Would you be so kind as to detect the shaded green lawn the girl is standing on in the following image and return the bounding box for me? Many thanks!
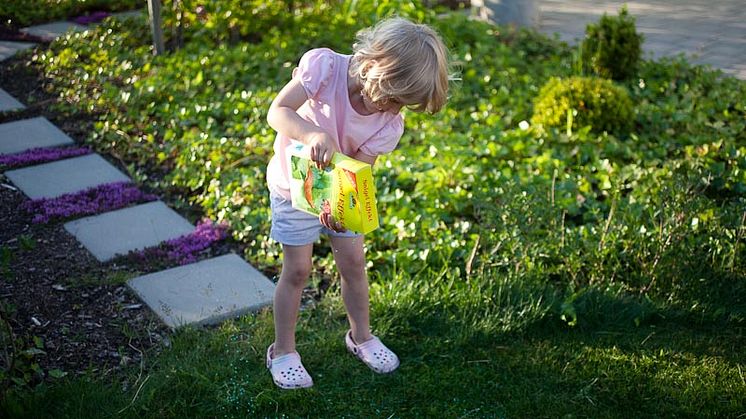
[0,278,746,418]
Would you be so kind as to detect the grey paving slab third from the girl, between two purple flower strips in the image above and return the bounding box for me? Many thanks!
[5,154,130,199]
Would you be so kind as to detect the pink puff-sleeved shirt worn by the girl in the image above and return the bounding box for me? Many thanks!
[267,48,404,199]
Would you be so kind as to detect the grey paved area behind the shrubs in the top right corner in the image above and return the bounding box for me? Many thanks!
[537,0,746,80]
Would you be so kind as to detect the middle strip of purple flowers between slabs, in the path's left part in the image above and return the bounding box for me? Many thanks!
[21,182,158,223]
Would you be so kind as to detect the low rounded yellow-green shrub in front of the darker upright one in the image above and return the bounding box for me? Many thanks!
[532,77,632,134]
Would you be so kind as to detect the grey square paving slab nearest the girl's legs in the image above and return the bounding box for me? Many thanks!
[127,254,275,328]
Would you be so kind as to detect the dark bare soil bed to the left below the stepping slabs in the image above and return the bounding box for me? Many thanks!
[0,180,168,383]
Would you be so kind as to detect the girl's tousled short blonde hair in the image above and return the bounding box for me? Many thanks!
[349,17,449,113]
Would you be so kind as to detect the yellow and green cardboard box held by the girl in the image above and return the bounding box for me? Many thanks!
[286,143,378,234]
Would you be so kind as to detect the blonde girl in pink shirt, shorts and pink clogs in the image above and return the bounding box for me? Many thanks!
[267,18,448,388]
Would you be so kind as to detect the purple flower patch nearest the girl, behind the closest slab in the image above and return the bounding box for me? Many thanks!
[135,218,228,265]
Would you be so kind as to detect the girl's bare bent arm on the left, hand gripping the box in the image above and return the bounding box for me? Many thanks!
[267,79,339,166]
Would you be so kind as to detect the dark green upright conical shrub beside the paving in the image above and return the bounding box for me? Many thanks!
[582,6,643,80]
